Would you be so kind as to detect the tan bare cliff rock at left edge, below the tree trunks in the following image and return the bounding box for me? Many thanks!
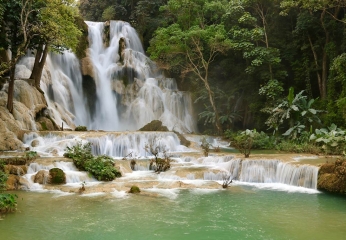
[0,80,55,151]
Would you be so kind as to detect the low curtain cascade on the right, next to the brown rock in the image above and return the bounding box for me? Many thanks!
[239,160,319,189]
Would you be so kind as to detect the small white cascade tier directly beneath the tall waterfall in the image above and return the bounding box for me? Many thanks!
[87,132,190,158]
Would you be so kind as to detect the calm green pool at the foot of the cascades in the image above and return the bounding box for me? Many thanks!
[0,186,346,239]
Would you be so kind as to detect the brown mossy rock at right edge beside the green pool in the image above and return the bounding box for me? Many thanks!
[317,159,346,194]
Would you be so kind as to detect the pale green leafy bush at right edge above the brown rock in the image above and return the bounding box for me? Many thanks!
[310,124,346,154]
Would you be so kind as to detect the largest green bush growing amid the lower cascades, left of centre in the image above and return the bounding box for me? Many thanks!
[64,143,121,181]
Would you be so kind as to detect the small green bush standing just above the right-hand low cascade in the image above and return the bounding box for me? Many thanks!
[231,129,258,158]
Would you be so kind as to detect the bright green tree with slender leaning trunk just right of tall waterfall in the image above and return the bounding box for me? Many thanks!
[148,0,231,133]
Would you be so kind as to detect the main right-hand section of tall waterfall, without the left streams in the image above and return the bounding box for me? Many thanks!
[86,21,196,132]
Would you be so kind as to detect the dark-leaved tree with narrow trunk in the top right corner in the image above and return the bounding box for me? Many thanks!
[280,0,346,99]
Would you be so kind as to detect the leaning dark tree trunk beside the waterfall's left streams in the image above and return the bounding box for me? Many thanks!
[30,44,48,93]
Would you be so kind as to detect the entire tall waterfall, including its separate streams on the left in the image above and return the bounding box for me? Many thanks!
[16,21,196,133]
